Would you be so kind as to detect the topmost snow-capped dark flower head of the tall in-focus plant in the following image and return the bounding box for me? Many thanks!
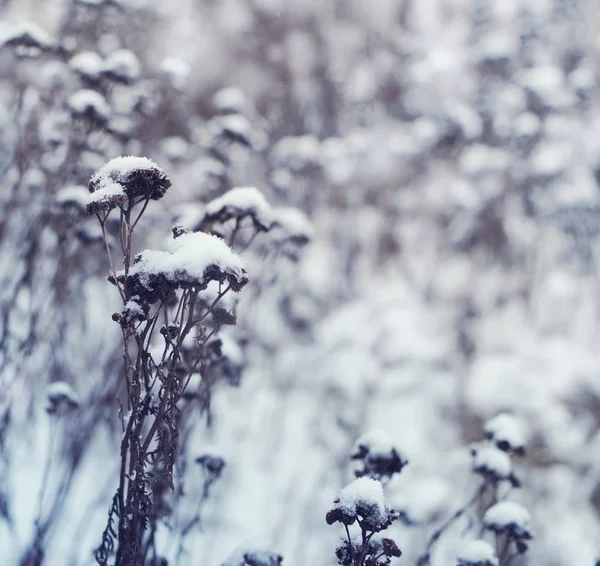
[89,156,171,204]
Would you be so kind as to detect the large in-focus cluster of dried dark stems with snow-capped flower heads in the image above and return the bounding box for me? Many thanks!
[86,156,308,566]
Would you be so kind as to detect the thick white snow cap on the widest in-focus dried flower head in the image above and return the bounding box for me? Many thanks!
[129,232,243,280]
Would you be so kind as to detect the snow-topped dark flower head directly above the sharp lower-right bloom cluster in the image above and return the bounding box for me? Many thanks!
[350,430,408,481]
